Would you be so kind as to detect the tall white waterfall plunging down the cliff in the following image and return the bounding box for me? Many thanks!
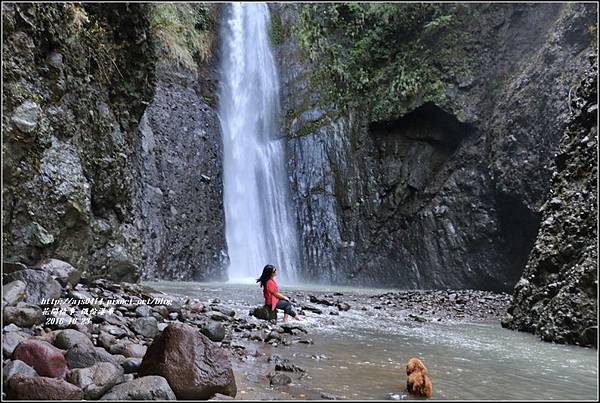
[219,3,298,283]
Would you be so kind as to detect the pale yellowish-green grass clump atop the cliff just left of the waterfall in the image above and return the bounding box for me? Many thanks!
[150,3,215,68]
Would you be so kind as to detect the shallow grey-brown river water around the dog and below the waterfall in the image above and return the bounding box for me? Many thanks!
[148,281,598,400]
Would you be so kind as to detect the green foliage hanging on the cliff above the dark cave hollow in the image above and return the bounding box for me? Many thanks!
[295,3,455,120]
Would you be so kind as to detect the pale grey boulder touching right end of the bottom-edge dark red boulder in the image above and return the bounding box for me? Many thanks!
[67,362,123,400]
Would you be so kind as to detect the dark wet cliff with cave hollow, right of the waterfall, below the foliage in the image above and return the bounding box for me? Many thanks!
[271,4,596,290]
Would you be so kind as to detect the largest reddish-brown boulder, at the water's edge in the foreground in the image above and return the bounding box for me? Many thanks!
[139,323,237,400]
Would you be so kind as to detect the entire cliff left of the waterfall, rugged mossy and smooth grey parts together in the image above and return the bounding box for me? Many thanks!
[2,3,227,282]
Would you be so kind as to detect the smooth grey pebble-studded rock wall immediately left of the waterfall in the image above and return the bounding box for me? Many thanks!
[136,63,227,280]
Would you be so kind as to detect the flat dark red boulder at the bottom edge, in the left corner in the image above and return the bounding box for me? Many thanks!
[8,374,83,400]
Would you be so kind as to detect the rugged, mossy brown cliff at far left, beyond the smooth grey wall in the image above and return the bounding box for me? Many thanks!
[2,3,153,280]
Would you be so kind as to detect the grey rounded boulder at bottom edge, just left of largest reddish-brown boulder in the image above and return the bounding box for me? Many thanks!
[100,376,177,400]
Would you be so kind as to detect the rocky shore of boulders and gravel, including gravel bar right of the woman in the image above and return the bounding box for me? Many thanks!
[2,259,510,400]
